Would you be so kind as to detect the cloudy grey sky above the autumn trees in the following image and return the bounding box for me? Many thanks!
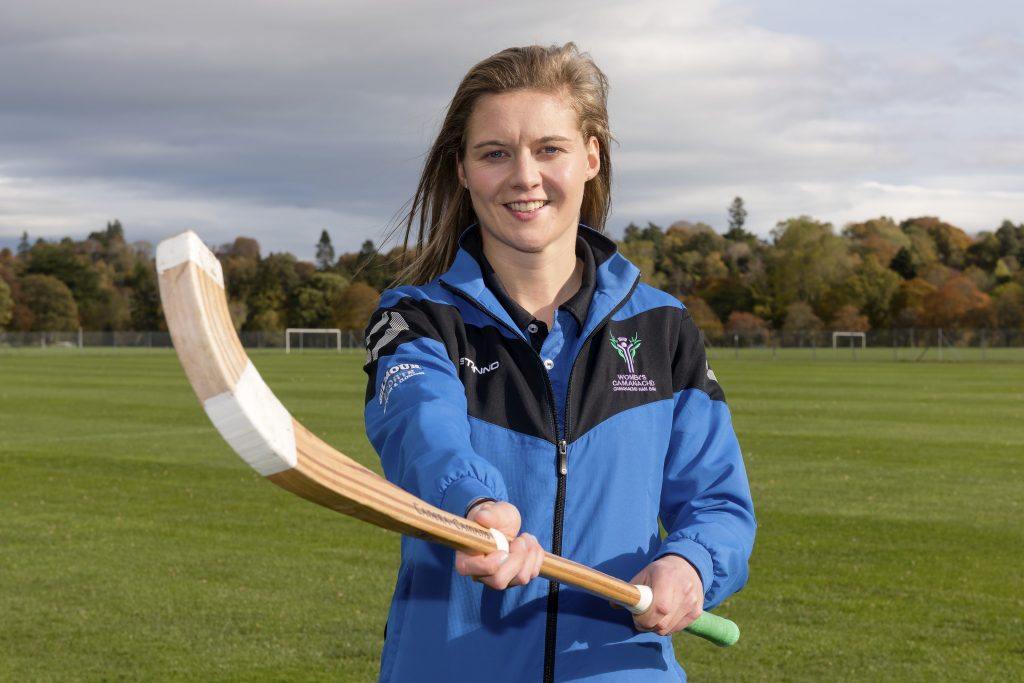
[0,0,1024,258]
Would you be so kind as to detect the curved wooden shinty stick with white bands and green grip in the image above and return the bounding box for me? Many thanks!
[157,231,739,647]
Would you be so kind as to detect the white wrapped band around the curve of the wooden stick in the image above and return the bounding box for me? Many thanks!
[203,360,298,476]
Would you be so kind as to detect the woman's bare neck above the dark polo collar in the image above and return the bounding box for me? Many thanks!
[483,242,583,329]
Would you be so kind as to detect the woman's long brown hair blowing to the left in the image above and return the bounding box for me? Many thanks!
[395,43,612,285]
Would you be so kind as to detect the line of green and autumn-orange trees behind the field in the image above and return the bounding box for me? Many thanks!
[0,198,1024,339]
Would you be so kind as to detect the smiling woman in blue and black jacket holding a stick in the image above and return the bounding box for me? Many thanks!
[366,43,755,682]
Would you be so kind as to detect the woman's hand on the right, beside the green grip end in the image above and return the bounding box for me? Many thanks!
[630,555,703,636]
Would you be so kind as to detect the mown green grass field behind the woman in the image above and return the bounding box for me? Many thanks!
[0,349,1024,682]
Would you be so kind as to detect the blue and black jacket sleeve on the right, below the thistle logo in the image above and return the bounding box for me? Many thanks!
[657,311,757,609]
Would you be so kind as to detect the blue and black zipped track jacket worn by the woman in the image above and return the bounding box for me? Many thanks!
[366,226,755,683]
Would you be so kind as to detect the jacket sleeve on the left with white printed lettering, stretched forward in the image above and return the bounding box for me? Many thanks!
[364,292,508,515]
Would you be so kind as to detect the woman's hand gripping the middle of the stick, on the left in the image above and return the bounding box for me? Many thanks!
[455,502,544,590]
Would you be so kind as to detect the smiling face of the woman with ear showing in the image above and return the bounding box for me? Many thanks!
[459,90,601,256]
